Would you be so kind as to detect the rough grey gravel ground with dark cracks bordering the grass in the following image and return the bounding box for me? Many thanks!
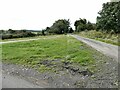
[2,53,118,88]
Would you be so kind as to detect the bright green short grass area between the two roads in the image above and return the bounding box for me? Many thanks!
[2,35,94,70]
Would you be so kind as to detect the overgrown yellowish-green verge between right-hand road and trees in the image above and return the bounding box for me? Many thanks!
[79,30,120,46]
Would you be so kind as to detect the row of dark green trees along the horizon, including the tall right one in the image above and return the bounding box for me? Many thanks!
[43,2,120,34]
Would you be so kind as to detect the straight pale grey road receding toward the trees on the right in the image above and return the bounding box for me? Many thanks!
[70,35,120,61]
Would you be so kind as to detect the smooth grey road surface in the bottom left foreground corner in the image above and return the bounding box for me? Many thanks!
[2,73,42,88]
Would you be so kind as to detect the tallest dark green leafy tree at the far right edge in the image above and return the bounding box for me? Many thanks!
[97,2,120,33]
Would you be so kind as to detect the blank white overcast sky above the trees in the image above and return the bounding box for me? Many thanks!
[0,0,110,30]
